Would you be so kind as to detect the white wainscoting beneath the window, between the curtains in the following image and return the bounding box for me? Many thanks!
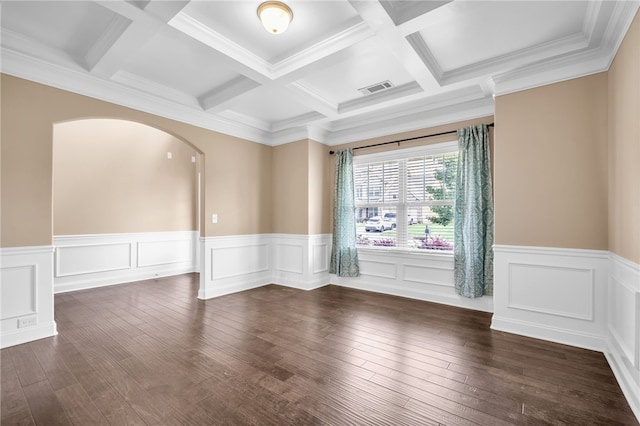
[331,249,493,312]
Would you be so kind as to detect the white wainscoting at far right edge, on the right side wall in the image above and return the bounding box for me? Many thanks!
[605,253,640,421]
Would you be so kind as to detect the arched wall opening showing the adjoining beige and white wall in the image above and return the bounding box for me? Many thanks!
[52,118,202,292]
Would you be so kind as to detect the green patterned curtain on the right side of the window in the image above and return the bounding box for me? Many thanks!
[453,124,493,298]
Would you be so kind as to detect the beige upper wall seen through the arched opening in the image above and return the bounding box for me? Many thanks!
[53,119,199,235]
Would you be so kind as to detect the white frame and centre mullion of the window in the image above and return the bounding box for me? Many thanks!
[353,140,458,256]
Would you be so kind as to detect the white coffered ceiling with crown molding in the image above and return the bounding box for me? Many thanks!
[0,0,640,145]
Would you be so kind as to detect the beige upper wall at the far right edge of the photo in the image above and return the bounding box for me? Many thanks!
[608,14,640,263]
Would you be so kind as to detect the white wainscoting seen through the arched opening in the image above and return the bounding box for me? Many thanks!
[53,231,199,293]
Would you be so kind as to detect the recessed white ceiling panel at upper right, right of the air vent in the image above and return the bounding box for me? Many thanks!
[420,1,587,71]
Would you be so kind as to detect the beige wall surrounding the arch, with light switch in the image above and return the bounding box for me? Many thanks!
[0,74,272,247]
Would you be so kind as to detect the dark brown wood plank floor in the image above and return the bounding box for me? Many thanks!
[1,274,638,426]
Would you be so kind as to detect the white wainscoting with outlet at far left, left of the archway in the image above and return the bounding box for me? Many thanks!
[0,246,57,348]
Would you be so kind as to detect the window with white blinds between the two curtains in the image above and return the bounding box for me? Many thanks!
[354,142,458,251]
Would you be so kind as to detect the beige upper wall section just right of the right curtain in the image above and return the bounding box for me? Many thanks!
[494,73,607,250]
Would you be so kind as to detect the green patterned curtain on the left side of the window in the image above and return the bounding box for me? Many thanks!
[329,149,360,277]
